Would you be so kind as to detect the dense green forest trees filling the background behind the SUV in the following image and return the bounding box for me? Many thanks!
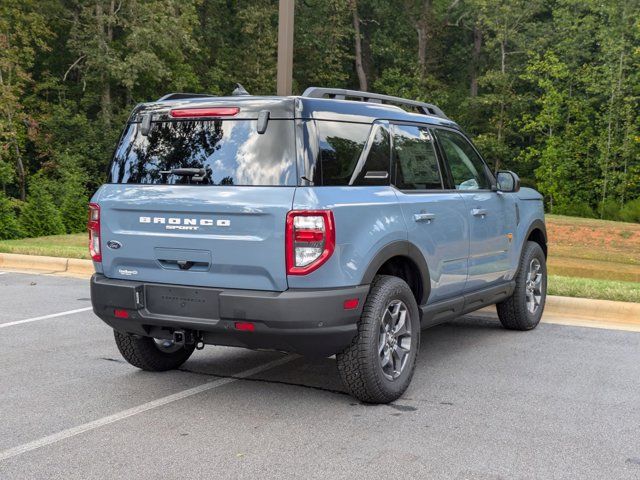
[0,0,640,235]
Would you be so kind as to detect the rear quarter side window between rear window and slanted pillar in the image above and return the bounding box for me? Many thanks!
[317,120,371,186]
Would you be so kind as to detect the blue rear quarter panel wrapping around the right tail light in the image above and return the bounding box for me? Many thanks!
[288,187,407,288]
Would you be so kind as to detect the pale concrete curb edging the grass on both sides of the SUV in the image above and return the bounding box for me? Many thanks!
[0,253,640,331]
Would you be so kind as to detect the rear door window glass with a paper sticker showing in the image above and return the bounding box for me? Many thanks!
[393,125,442,190]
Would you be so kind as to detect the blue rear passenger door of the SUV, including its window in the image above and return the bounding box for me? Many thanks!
[392,124,469,304]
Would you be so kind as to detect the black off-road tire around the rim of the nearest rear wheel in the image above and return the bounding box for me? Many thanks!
[336,275,420,403]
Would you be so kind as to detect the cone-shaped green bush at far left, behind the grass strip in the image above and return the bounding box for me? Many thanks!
[20,175,66,237]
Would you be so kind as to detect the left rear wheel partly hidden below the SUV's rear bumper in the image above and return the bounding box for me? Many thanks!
[113,330,195,372]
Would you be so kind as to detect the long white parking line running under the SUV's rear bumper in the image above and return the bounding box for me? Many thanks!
[0,355,298,462]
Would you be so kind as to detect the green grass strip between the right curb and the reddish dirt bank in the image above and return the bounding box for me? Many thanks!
[549,275,640,303]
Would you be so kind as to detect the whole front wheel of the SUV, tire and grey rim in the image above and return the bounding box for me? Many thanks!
[497,242,547,330]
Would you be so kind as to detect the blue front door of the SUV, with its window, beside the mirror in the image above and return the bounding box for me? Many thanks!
[435,128,516,291]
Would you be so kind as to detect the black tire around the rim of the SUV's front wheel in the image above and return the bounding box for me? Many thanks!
[496,242,547,331]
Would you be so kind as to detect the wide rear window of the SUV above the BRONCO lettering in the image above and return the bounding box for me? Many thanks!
[108,120,297,186]
